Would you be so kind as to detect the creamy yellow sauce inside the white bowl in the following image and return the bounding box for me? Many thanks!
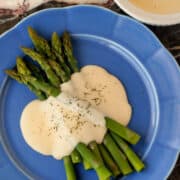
[129,0,180,14]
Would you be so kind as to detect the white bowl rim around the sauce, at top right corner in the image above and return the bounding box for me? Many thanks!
[114,0,180,26]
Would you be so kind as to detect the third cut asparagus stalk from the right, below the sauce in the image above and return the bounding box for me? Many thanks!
[103,134,133,175]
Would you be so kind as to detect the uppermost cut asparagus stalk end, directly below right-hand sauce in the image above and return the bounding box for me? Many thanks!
[105,117,140,144]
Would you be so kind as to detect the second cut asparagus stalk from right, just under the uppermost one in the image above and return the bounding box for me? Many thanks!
[111,132,145,172]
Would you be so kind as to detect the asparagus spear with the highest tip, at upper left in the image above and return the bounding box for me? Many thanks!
[28,27,55,59]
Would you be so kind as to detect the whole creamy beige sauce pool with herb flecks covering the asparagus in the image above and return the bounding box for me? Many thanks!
[20,66,131,159]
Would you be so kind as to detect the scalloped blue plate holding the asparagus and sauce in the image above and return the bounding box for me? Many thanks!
[0,6,180,180]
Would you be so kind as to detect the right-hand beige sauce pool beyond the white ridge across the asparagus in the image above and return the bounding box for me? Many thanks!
[61,65,131,125]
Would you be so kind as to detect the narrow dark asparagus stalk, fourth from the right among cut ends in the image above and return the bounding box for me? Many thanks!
[98,144,121,177]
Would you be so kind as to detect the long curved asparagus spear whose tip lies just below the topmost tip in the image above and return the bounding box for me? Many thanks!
[21,47,60,87]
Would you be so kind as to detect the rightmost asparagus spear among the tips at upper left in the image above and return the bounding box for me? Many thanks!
[62,32,79,72]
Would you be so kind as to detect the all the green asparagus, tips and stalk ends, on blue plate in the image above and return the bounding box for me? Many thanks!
[6,27,144,180]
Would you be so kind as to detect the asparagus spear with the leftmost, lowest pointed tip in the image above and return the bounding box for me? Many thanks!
[5,70,46,100]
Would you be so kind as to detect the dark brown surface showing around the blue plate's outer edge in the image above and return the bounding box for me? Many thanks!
[0,2,180,180]
